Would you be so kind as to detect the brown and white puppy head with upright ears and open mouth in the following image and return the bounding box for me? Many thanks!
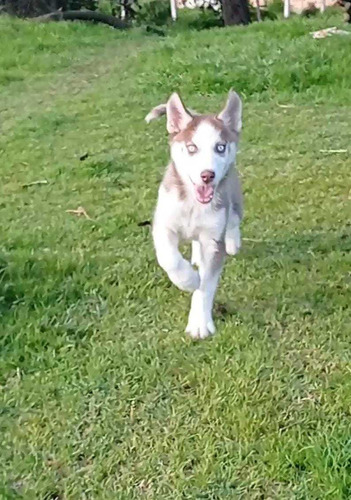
[166,91,242,204]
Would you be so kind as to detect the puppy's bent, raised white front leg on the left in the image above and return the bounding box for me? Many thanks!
[153,225,200,292]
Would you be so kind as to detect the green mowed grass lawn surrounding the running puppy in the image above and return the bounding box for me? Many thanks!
[0,9,351,500]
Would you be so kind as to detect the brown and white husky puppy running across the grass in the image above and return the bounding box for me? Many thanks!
[145,91,242,338]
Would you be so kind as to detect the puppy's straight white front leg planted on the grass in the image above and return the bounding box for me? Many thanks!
[186,240,225,339]
